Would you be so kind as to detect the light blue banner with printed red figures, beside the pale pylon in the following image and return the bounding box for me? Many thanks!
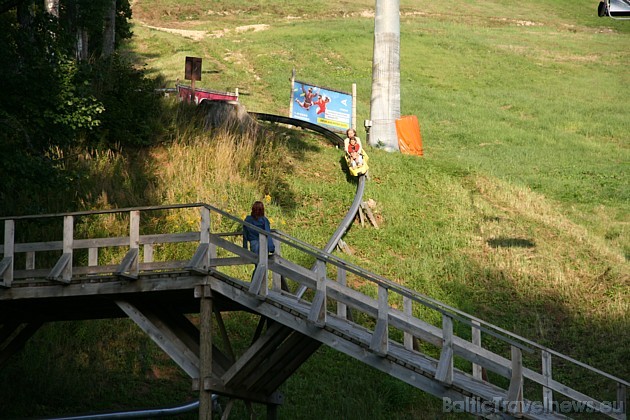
[291,80,352,132]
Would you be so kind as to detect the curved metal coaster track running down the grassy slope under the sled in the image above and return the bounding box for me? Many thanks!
[249,112,365,299]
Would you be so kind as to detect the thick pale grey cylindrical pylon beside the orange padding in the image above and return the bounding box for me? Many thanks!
[369,0,400,152]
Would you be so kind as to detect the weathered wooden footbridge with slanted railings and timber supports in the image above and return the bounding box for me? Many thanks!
[0,204,628,419]
